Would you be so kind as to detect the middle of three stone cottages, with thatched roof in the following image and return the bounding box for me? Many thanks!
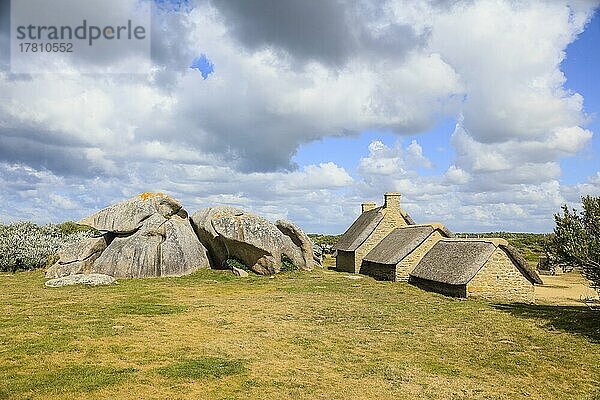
[360,223,453,282]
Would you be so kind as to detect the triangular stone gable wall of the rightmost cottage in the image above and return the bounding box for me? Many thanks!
[467,247,535,303]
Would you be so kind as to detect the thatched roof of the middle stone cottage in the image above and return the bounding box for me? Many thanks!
[364,224,452,265]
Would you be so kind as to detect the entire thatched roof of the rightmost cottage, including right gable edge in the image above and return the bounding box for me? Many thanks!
[410,239,543,285]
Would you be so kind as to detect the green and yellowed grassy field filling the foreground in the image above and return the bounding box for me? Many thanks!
[0,264,600,400]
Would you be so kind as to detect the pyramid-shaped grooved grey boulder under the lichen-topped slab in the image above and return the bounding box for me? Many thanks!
[92,214,209,278]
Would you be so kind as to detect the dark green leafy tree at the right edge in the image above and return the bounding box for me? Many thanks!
[549,196,600,293]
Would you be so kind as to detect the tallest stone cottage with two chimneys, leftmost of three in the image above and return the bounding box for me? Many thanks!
[335,192,415,273]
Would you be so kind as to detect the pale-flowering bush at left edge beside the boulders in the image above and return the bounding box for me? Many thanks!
[0,222,91,272]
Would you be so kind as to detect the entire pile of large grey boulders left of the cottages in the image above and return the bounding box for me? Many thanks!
[46,193,320,278]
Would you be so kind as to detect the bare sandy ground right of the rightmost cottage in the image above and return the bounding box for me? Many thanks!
[535,271,598,306]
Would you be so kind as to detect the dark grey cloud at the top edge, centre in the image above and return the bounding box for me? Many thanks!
[213,0,426,68]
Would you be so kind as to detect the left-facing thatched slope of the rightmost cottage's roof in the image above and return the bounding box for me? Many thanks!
[410,240,496,285]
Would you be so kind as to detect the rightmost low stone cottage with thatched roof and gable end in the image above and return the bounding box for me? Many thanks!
[409,239,543,303]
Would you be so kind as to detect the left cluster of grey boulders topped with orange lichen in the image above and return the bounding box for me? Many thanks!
[46,193,209,278]
